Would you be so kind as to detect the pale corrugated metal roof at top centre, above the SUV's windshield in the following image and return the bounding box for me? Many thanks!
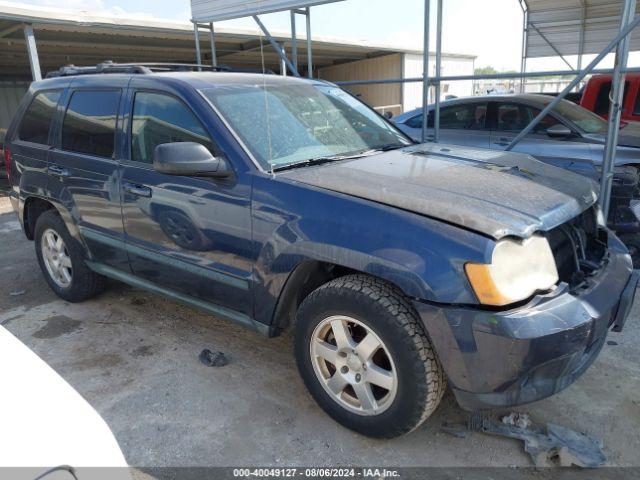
[191,0,342,22]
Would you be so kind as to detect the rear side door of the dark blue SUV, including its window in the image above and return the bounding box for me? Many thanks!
[48,75,129,270]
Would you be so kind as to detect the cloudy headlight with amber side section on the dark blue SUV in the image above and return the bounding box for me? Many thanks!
[465,235,558,306]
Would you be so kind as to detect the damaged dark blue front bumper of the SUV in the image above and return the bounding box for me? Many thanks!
[414,236,638,410]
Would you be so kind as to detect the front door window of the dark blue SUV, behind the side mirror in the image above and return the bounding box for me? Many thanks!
[131,92,215,163]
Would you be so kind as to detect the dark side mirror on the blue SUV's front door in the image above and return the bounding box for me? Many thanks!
[153,142,231,178]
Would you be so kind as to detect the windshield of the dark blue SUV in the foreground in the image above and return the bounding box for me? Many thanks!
[203,82,411,169]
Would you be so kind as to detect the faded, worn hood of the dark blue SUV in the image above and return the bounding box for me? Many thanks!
[278,144,597,239]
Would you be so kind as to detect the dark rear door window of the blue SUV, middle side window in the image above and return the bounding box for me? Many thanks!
[62,90,120,158]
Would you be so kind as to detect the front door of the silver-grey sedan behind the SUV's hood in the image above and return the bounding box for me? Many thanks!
[491,102,593,174]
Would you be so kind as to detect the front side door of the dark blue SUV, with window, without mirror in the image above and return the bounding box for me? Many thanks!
[121,89,253,316]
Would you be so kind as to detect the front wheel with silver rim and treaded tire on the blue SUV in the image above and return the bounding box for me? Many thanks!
[295,274,446,438]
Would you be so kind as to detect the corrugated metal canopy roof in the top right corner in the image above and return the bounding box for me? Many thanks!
[524,0,640,58]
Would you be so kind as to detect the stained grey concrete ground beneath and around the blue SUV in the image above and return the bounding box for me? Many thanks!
[0,177,640,467]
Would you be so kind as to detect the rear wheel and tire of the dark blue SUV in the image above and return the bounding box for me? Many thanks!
[34,210,105,302]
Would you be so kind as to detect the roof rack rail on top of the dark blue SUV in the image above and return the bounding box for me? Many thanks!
[46,60,232,78]
